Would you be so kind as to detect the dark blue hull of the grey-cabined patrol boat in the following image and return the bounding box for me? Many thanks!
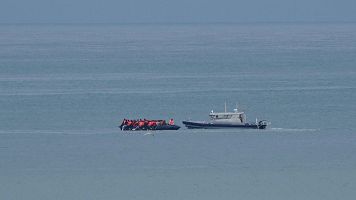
[183,121,267,129]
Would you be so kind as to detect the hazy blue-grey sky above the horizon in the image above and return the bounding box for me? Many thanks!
[0,0,356,23]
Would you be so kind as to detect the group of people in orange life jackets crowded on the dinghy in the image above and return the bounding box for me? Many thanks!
[120,119,174,130]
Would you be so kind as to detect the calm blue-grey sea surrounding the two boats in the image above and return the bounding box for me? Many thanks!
[0,22,356,200]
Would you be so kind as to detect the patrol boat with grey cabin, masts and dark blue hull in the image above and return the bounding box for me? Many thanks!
[183,103,269,129]
